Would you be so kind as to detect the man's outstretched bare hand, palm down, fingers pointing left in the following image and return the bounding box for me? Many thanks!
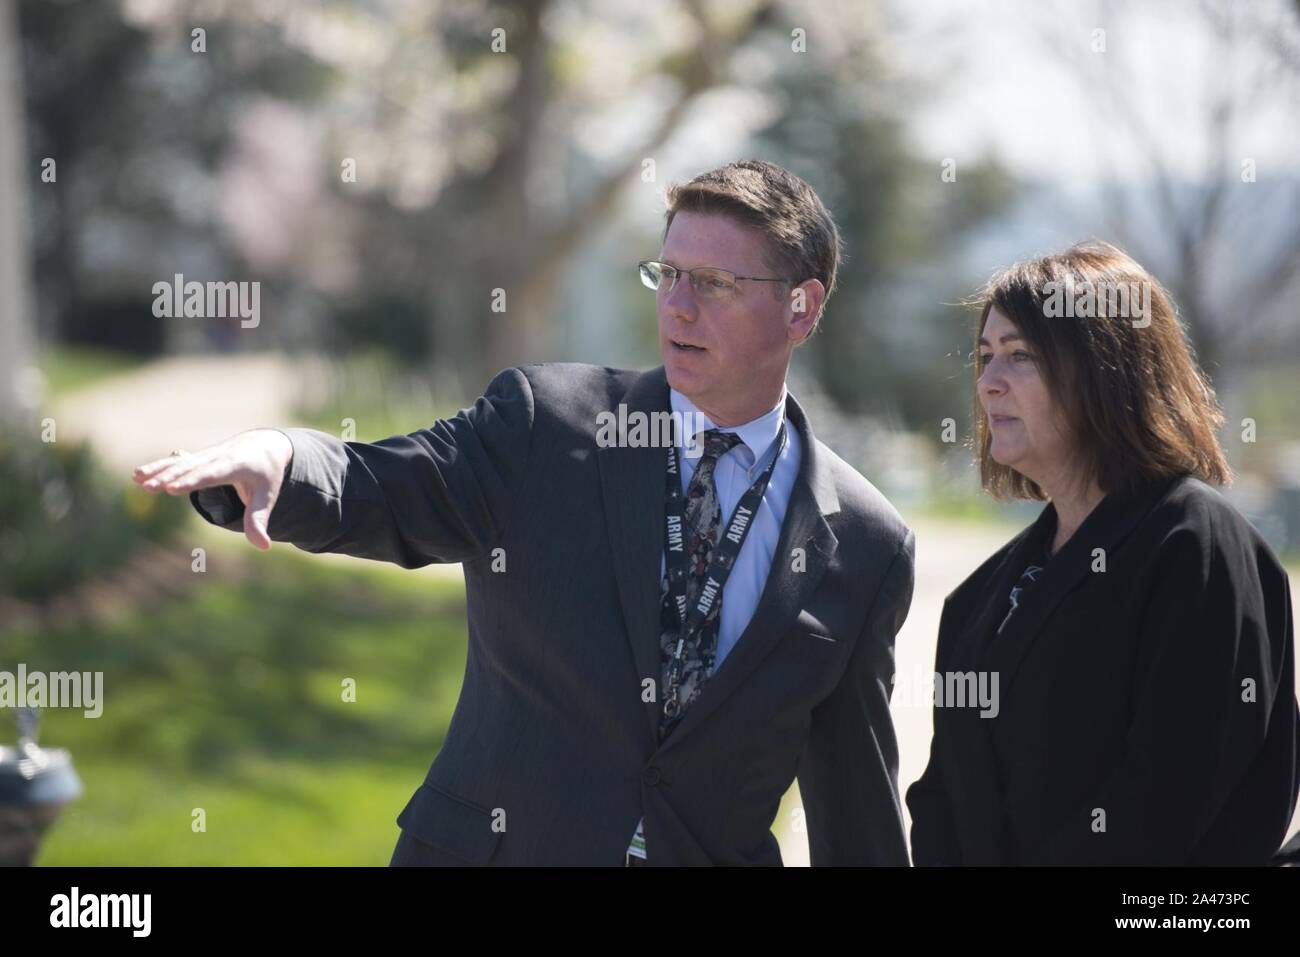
[131,429,294,551]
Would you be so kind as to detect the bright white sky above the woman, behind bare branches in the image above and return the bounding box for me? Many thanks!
[889,0,1300,186]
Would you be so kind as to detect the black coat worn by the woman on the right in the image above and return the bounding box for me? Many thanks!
[907,477,1300,865]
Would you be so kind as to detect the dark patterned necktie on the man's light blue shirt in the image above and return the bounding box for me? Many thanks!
[659,429,740,740]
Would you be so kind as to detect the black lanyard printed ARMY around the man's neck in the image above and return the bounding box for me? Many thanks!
[663,420,785,718]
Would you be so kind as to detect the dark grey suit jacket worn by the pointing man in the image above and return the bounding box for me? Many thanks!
[195,363,914,865]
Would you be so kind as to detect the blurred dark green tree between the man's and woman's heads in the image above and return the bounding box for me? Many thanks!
[758,5,1015,428]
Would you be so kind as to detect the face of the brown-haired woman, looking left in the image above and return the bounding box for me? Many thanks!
[975,306,1073,486]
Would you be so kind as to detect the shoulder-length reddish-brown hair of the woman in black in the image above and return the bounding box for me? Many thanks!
[974,241,1232,501]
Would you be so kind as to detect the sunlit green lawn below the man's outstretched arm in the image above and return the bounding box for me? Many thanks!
[0,532,467,865]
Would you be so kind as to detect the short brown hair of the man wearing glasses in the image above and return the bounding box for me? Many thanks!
[663,160,842,325]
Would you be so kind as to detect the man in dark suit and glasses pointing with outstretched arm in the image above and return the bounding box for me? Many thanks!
[137,161,914,865]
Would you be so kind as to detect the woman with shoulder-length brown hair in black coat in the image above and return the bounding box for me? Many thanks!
[907,243,1300,865]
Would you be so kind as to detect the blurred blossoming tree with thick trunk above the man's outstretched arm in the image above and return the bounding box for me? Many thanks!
[314,0,776,387]
